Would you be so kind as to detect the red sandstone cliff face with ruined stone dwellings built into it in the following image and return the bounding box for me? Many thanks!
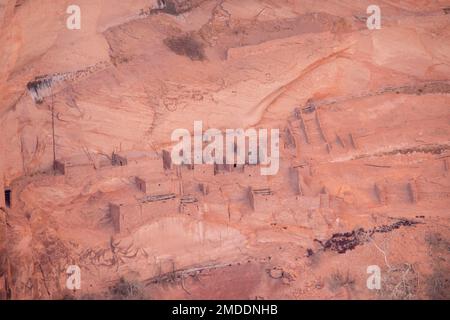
[0,0,450,299]
